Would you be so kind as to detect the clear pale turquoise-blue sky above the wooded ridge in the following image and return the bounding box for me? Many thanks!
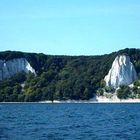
[0,0,140,55]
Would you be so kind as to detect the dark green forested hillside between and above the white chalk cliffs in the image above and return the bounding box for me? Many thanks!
[0,49,140,102]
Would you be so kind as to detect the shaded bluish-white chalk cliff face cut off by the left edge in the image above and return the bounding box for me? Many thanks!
[0,58,35,80]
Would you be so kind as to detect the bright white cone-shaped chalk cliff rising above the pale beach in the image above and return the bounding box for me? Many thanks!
[104,55,137,88]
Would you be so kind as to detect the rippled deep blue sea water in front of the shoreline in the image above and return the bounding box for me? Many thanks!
[0,103,140,140]
